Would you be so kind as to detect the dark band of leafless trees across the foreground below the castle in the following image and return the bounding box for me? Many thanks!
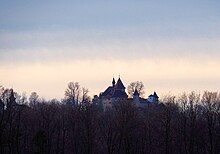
[0,89,220,154]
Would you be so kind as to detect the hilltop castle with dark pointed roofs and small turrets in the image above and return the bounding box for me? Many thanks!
[99,77,159,110]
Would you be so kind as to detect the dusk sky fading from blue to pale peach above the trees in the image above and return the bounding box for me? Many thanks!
[0,0,220,99]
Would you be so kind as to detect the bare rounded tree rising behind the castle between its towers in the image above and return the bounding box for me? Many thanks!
[127,81,145,97]
